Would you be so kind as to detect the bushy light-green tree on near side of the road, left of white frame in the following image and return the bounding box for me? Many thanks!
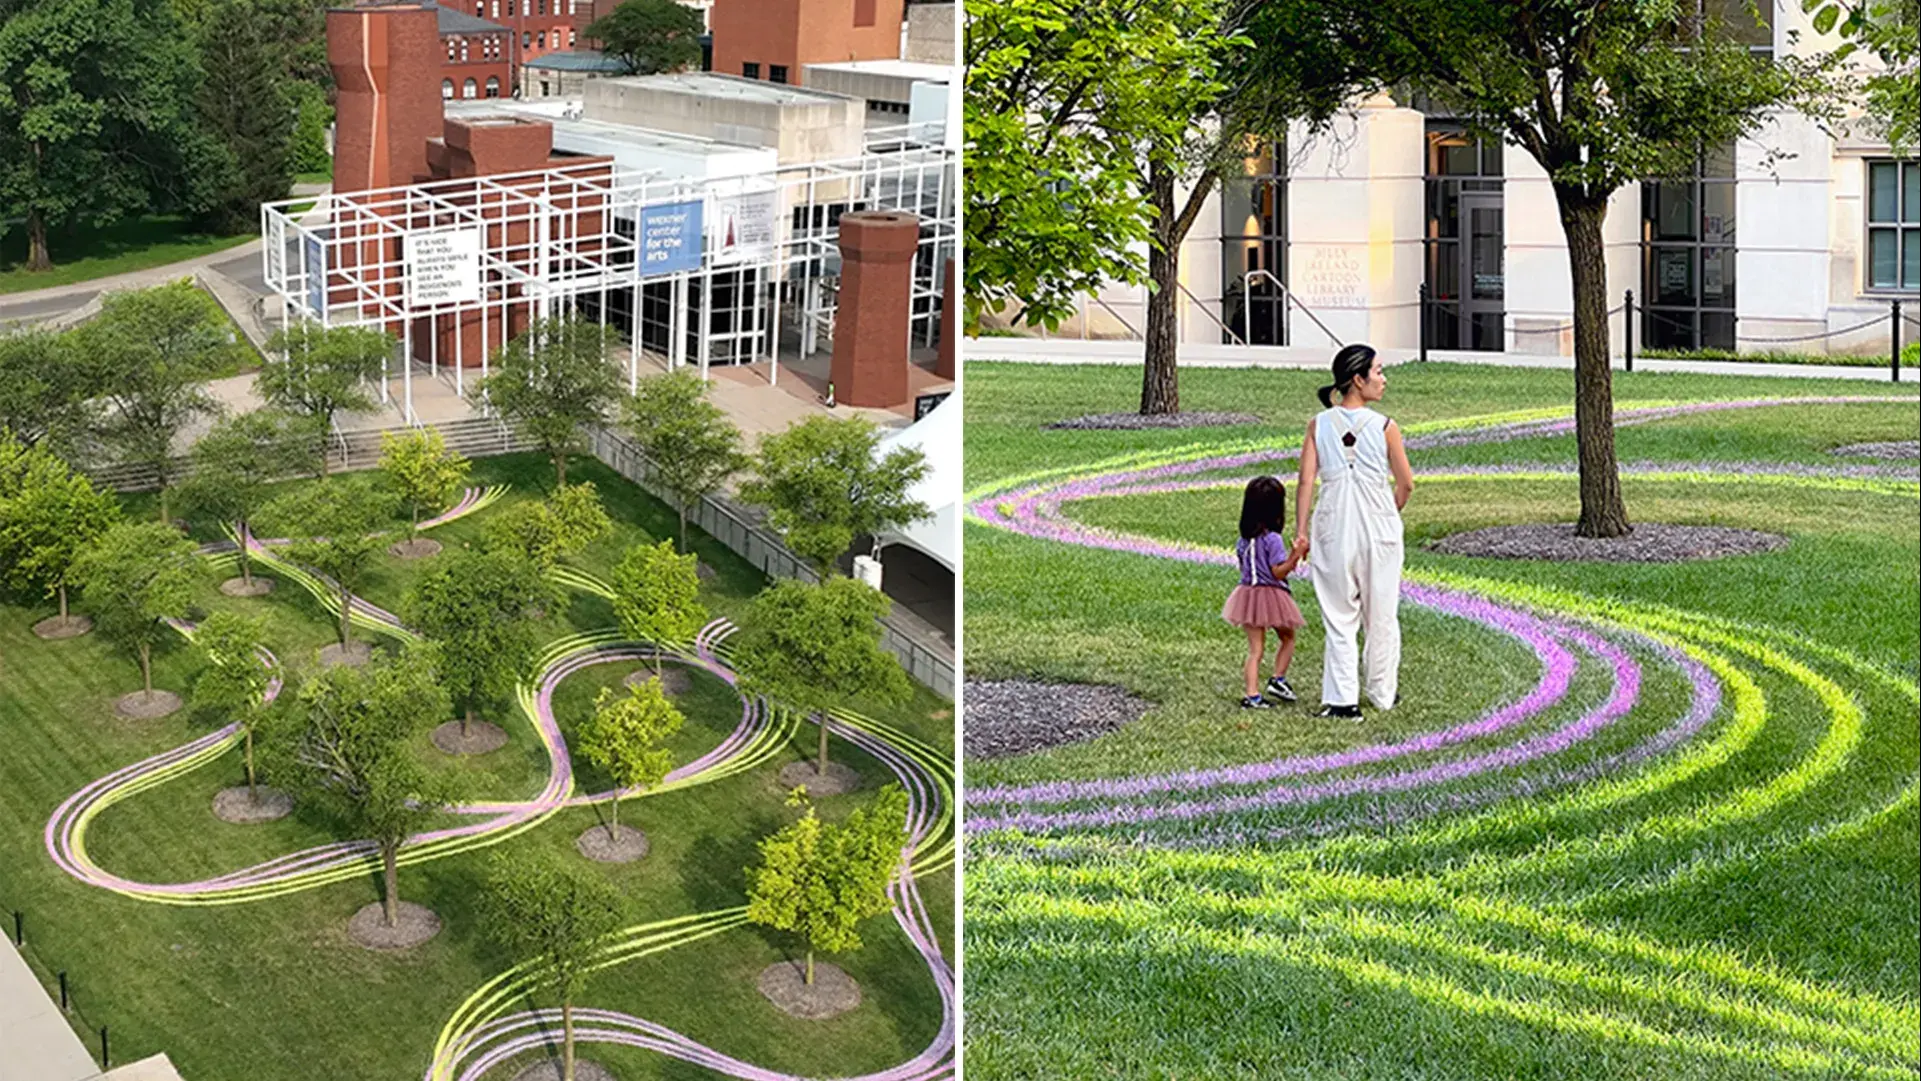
[75,280,244,522]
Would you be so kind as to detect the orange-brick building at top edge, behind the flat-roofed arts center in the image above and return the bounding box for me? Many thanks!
[711,0,907,84]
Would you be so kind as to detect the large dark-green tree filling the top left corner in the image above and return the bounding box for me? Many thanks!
[0,0,200,271]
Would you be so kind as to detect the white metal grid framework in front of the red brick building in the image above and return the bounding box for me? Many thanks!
[261,136,959,422]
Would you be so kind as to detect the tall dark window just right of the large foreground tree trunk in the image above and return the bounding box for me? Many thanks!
[1639,146,1735,351]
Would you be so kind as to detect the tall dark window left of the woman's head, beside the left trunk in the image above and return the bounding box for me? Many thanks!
[1220,142,1287,346]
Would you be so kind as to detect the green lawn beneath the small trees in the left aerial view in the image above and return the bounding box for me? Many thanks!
[0,455,953,1081]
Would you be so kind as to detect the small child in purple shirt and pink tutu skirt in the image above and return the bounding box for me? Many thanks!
[1220,476,1306,709]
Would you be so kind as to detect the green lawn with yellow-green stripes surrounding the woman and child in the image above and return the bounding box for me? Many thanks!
[964,363,1921,1081]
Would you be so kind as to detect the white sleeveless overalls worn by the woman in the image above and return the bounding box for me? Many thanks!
[1297,405,1404,709]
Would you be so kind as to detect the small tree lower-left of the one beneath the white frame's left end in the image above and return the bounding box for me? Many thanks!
[181,409,319,591]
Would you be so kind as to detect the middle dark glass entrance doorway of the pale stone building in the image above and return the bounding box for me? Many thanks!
[1425,121,1508,351]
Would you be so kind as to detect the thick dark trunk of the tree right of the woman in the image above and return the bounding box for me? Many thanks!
[1554,188,1633,538]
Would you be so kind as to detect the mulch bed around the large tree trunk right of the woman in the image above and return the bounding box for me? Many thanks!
[1427,522,1788,563]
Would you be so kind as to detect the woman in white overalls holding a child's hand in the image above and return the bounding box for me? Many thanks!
[1295,346,1414,720]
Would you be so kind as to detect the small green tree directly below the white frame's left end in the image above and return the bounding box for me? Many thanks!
[254,323,394,476]
